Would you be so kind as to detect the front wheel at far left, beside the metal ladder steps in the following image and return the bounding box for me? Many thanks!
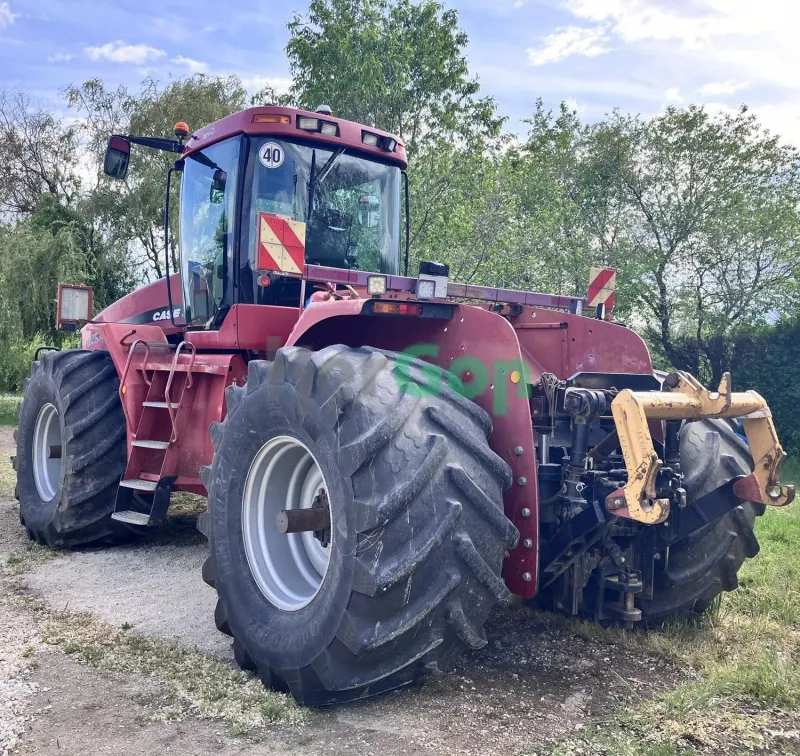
[15,349,140,546]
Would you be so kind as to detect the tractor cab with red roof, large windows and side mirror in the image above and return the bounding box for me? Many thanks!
[106,107,407,329]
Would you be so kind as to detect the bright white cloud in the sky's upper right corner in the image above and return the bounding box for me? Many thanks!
[556,0,800,145]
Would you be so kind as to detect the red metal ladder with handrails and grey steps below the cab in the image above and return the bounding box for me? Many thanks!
[111,339,196,526]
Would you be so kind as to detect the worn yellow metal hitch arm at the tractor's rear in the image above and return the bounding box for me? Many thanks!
[606,372,795,525]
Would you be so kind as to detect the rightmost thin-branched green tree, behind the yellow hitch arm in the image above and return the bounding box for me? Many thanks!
[614,106,800,384]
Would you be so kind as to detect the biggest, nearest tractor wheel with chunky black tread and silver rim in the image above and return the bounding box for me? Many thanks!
[203,346,518,705]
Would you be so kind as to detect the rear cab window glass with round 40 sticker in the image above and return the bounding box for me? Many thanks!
[242,137,400,274]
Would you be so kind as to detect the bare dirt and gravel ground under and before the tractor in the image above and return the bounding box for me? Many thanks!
[0,427,685,756]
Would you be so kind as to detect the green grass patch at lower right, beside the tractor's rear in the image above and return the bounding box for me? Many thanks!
[554,460,800,756]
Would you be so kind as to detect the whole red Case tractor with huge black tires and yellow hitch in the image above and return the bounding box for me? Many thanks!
[16,107,794,704]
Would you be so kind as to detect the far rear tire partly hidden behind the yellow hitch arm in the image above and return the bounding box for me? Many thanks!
[637,420,764,622]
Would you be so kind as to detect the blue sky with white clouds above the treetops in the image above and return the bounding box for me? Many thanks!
[0,0,800,144]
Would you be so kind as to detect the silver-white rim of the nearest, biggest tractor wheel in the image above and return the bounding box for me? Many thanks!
[242,436,334,612]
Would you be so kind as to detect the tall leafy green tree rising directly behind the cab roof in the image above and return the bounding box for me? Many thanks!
[285,0,503,270]
